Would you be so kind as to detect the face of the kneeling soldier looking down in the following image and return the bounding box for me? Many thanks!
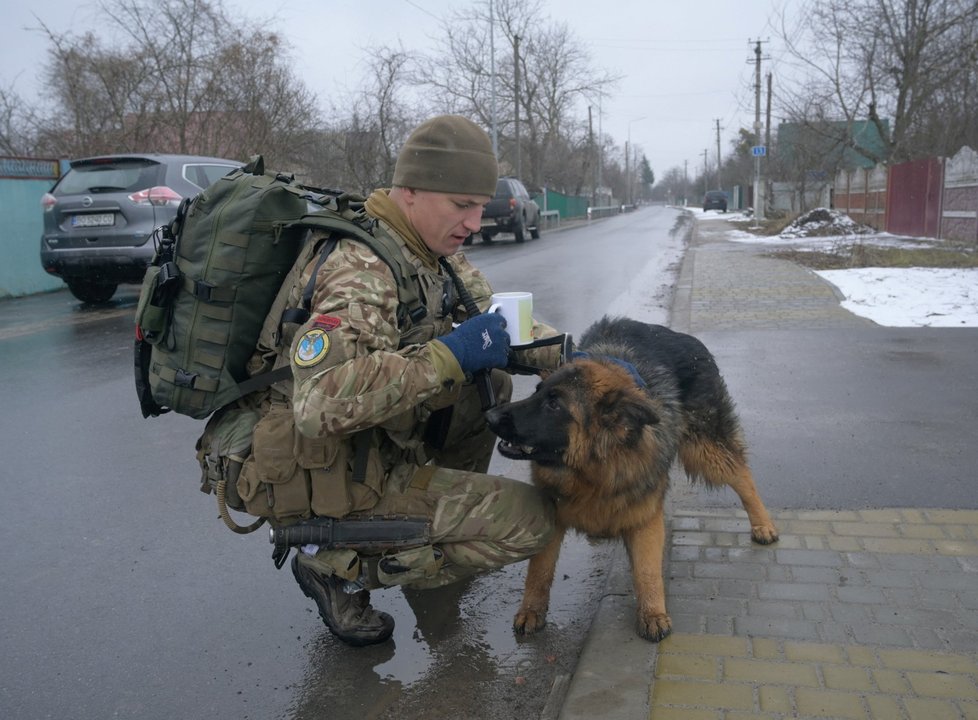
[405,190,492,257]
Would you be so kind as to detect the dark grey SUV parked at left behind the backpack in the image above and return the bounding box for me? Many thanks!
[41,154,241,303]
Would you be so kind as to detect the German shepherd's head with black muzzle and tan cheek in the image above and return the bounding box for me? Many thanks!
[486,360,659,469]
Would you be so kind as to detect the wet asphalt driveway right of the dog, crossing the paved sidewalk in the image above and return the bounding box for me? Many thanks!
[684,327,978,509]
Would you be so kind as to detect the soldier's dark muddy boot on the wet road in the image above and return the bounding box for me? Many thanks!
[292,555,394,646]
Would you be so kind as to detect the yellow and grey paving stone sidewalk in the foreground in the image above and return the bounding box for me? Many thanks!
[649,509,978,720]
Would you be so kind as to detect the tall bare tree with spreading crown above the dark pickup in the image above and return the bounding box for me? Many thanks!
[417,0,617,189]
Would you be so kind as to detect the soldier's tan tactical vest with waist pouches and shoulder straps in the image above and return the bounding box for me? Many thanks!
[198,227,468,529]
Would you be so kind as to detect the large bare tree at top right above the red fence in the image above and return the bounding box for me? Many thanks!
[779,0,978,162]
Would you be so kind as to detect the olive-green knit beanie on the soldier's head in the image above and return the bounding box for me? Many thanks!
[394,115,499,197]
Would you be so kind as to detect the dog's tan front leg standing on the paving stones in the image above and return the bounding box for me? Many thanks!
[623,507,672,642]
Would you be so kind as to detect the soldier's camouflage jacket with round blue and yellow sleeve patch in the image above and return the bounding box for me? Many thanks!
[260,215,559,487]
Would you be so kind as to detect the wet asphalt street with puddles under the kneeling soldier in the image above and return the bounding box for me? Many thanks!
[0,208,677,720]
